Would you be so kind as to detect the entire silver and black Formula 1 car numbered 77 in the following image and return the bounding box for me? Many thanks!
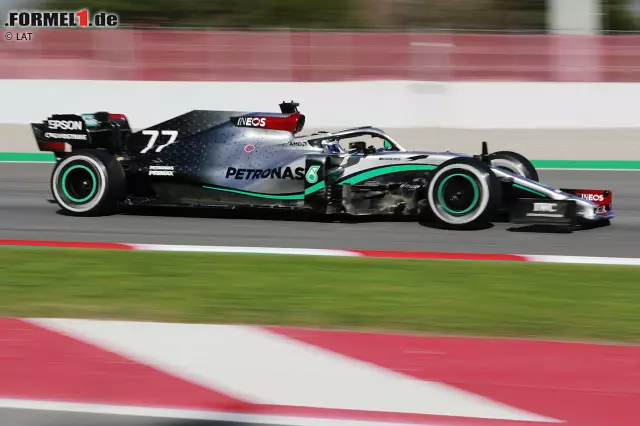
[31,101,614,229]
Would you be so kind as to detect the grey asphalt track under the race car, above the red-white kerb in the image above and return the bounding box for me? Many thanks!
[0,163,640,257]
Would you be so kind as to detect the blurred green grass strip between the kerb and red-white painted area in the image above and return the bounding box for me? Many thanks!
[0,248,640,342]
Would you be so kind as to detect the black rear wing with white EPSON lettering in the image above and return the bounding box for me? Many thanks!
[31,112,131,157]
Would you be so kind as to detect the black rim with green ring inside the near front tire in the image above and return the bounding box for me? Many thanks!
[437,173,480,215]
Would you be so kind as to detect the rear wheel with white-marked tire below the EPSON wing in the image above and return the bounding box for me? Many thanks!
[51,149,126,216]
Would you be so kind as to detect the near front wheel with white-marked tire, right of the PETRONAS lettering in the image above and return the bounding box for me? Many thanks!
[427,158,502,229]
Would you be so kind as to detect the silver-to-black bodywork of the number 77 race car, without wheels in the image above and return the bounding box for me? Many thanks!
[33,104,613,225]
